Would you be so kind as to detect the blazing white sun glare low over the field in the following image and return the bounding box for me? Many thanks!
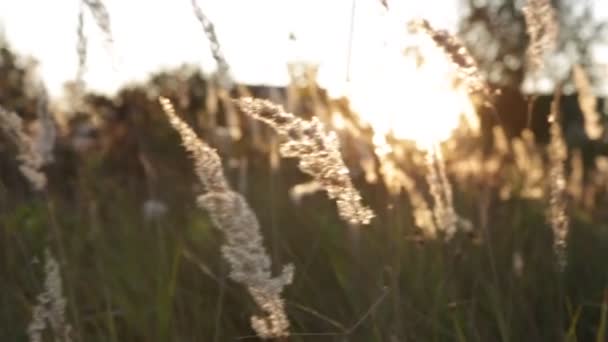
[347,29,478,150]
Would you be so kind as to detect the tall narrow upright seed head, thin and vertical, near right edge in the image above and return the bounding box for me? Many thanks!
[548,95,570,270]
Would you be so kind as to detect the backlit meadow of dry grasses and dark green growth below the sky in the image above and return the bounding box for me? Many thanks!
[0,0,608,342]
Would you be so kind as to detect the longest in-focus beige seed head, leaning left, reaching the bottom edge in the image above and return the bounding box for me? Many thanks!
[159,97,294,338]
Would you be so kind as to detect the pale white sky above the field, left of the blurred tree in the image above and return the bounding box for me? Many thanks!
[0,0,608,94]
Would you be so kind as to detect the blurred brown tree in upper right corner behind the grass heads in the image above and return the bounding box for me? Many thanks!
[459,0,608,147]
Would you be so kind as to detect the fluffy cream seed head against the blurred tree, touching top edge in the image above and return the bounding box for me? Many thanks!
[522,0,559,71]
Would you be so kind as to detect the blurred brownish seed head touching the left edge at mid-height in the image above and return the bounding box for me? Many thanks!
[0,106,46,191]
